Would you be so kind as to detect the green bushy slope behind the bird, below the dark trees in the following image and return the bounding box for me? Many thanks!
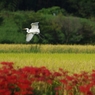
[0,6,95,44]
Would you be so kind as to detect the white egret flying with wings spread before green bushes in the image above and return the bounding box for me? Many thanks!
[24,22,40,42]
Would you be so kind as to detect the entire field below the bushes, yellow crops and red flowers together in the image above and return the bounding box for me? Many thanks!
[0,44,95,95]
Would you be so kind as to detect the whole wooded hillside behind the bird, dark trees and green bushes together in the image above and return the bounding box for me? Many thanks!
[0,0,95,44]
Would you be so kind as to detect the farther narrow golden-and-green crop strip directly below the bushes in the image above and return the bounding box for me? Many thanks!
[0,44,95,54]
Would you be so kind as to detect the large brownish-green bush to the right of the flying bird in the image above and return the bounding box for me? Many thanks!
[52,15,95,44]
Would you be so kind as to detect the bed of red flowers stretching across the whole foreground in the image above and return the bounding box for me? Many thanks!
[0,62,95,95]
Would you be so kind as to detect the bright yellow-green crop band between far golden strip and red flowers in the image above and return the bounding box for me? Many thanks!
[0,53,95,73]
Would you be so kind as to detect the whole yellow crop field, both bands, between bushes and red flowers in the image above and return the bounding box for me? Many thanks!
[0,44,95,73]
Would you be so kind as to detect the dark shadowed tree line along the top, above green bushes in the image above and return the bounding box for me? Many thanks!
[0,0,95,18]
